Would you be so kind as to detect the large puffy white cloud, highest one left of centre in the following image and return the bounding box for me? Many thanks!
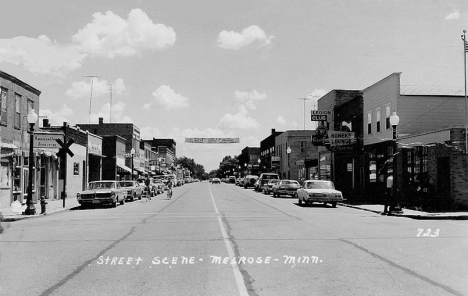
[73,9,176,58]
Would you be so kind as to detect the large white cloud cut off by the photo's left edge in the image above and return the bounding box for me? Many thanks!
[0,35,86,76]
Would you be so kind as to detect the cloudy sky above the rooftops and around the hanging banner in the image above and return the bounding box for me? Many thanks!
[0,0,468,172]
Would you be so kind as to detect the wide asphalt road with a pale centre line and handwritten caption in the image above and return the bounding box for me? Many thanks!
[0,182,468,295]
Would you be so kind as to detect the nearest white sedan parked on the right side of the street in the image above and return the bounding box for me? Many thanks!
[297,180,343,207]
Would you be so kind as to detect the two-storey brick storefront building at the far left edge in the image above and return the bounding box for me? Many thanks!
[0,71,45,211]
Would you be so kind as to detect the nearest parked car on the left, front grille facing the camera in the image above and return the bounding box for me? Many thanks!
[76,180,127,208]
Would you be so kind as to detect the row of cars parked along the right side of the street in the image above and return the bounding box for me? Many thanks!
[235,173,343,207]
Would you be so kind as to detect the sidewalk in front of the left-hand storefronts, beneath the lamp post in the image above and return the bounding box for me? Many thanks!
[1,198,80,222]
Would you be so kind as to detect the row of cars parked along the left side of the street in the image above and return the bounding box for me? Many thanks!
[76,178,176,207]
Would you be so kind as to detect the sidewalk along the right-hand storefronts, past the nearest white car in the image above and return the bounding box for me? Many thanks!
[338,203,468,220]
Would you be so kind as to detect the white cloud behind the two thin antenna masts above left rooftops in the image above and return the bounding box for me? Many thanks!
[65,78,127,99]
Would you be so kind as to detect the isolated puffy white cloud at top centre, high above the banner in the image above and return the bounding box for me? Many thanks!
[217,25,274,50]
